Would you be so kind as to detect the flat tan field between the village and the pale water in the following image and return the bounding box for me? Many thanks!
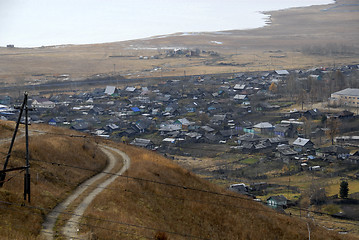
[0,0,359,91]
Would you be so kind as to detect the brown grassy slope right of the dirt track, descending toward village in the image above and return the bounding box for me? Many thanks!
[83,143,354,239]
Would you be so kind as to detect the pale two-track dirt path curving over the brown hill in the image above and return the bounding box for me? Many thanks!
[41,146,130,239]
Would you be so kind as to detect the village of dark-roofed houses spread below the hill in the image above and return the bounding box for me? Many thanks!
[0,65,359,225]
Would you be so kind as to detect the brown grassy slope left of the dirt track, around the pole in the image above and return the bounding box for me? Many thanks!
[0,121,106,239]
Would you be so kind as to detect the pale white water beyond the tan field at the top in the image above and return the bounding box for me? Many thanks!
[0,0,334,47]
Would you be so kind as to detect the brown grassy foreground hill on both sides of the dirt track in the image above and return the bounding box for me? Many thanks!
[0,122,358,239]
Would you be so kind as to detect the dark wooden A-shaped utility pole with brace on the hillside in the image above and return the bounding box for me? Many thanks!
[0,92,31,202]
